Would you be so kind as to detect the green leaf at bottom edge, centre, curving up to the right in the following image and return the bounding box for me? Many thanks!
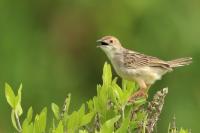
[100,115,121,133]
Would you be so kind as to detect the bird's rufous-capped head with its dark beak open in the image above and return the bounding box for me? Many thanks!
[97,36,122,54]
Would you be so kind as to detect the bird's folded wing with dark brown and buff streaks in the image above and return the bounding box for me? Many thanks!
[123,50,171,70]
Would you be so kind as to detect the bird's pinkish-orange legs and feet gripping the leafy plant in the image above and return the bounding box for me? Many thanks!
[128,80,150,102]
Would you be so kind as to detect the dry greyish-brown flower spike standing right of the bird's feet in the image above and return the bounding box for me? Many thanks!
[146,88,168,133]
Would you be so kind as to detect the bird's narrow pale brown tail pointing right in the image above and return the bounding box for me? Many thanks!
[168,57,192,68]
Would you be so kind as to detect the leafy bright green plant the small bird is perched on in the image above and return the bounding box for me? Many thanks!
[5,63,188,133]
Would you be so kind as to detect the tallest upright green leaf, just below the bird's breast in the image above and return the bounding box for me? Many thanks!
[102,62,112,85]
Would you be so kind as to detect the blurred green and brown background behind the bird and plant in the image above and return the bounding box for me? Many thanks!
[0,0,200,133]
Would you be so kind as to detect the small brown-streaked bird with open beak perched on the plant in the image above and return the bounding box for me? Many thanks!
[97,36,192,102]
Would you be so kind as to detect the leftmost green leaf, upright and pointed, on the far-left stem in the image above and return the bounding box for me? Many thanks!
[5,83,15,109]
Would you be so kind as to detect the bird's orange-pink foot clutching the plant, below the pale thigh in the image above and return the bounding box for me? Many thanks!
[128,89,148,103]
